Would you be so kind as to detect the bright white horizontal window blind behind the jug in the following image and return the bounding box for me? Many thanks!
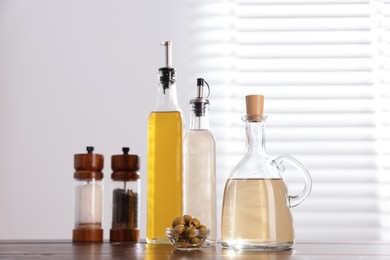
[188,0,390,241]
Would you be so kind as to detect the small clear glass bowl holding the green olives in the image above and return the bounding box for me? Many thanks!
[165,228,210,250]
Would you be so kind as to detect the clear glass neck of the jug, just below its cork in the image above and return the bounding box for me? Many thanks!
[246,120,267,157]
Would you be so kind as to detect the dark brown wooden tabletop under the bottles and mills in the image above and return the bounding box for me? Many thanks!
[0,241,390,260]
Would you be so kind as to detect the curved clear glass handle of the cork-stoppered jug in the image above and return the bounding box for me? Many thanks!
[272,155,312,208]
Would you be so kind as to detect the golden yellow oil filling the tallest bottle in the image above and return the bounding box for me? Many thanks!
[146,111,183,243]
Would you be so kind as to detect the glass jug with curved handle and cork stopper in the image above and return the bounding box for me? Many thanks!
[222,95,311,251]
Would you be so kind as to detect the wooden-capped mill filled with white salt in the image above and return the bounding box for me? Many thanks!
[73,146,104,242]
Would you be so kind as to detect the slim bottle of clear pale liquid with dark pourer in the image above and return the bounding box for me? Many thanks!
[183,78,217,246]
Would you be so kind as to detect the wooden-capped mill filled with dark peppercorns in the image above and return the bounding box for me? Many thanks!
[110,147,140,242]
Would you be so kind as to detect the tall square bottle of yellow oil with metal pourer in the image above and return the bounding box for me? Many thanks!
[146,42,183,244]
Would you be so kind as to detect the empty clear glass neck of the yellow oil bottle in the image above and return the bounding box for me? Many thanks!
[156,84,180,111]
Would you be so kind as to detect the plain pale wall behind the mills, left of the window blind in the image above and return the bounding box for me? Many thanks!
[0,0,195,239]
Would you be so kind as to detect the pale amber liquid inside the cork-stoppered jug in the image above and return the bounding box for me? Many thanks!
[222,179,294,249]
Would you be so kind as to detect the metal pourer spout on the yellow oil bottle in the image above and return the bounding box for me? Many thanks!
[158,41,176,94]
